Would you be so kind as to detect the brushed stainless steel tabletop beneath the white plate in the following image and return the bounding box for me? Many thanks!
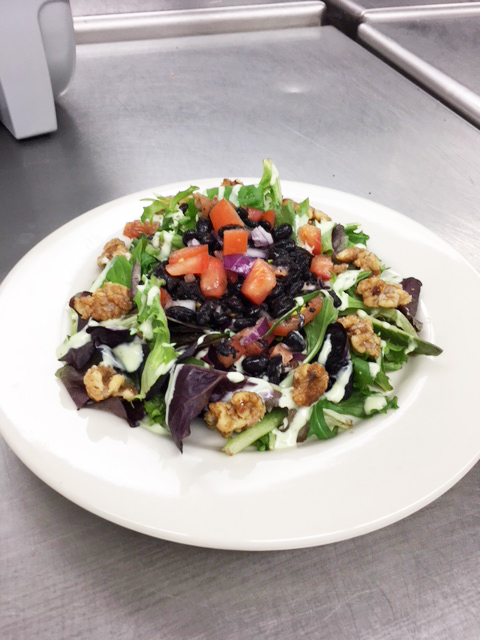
[0,27,480,640]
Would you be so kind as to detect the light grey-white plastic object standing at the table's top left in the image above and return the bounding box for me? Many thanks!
[0,0,75,139]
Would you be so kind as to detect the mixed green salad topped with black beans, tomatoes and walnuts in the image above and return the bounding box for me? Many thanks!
[57,159,442,455]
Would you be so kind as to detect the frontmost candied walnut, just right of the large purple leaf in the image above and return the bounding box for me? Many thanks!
[205,391,265,436]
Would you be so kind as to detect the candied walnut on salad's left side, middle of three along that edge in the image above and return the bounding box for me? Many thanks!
[71,282,132,322]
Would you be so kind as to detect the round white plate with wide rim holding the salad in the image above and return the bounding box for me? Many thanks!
[0,179,480,550]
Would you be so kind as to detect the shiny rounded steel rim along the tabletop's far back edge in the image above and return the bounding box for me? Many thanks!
[74,0,325,44]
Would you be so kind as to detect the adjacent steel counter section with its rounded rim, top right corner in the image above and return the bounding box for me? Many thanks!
[358,15,480,126]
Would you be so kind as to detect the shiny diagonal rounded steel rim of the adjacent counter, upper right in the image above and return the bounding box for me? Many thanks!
[358,23,480,126]
